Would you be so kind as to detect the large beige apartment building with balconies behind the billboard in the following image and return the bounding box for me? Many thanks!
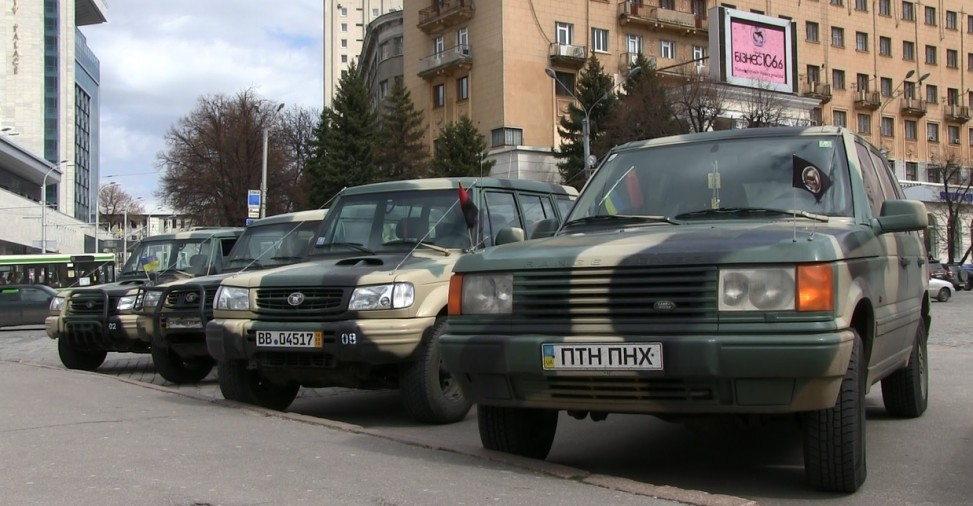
[394,0,973,191]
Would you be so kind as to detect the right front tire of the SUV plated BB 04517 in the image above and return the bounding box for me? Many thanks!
[399,318,473,424]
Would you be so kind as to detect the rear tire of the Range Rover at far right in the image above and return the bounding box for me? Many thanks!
[882,322,929,418]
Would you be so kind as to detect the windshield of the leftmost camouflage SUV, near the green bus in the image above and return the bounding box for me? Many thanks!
[122,239,213,276]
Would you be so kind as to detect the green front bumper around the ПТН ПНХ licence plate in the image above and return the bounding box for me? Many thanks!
[439,330,854,414]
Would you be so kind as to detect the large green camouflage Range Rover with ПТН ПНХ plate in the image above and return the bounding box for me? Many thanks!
[440,127,930,492]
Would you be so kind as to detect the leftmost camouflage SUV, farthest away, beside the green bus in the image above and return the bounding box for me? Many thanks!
[45,228,243,371]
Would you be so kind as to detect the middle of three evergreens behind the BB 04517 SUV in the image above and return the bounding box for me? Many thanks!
[375,81,429,180]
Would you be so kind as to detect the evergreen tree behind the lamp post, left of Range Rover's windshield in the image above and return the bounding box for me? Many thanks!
[554,55,618,189]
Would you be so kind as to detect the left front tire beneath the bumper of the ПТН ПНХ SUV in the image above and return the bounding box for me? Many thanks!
[476,405,558,460]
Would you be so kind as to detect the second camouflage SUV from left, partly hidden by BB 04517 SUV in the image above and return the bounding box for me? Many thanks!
[135,209,327,384]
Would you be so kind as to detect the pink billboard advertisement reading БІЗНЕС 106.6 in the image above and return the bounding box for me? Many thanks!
[728,18,789,84]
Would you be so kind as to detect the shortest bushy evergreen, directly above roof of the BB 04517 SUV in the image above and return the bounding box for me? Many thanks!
[430,116,496,177]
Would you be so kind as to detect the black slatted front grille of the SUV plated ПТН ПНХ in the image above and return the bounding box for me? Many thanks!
[513,266,718,323]
